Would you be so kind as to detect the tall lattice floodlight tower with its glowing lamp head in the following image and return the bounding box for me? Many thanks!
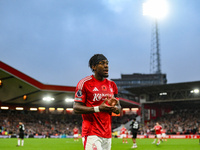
[143,0,168,74]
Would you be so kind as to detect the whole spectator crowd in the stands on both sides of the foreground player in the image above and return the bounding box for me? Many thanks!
[0,109,200,136]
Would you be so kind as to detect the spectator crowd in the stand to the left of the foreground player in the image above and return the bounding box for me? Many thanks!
[0,111,82,136]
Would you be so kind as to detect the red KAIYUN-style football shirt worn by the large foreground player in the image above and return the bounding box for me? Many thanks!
[74,75,118,138]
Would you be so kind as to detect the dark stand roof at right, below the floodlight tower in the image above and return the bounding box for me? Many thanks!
[127,81,200,104]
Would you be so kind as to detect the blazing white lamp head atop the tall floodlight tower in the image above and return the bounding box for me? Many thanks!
[143,0,168,19]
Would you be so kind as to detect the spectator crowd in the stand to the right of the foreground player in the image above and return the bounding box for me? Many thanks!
[142,109,200,135]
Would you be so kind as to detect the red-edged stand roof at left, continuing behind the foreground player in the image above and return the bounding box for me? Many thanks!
[0,61,140,108]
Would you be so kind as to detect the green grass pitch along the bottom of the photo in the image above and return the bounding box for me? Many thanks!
[0,138,200,150]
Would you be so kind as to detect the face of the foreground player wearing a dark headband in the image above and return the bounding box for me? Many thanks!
[95,60,108,78]
